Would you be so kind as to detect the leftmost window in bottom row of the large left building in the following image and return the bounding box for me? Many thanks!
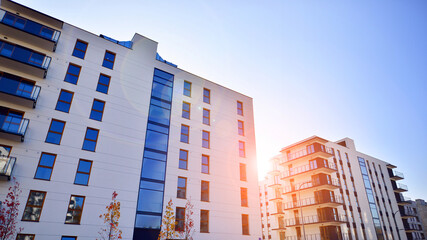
[22,190,46,222]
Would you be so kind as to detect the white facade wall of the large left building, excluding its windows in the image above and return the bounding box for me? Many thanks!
[0,0,261,240]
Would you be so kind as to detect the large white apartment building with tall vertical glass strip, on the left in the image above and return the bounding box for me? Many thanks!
[0,0,261,240]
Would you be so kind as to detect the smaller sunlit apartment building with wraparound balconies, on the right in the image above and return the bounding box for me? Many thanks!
[261,136,412,240]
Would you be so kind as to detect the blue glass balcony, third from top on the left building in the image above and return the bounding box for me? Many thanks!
[0,72,41,108]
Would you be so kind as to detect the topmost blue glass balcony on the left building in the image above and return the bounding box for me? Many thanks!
[0,9,61,51]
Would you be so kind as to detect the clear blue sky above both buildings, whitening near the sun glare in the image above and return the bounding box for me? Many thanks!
[18,0,427,199]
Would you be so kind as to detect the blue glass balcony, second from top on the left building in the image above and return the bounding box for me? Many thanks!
[0,40,51,78]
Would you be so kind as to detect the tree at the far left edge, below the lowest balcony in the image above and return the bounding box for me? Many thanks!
[0,177,23,240]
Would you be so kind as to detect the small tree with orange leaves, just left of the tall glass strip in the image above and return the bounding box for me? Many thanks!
[98,191,122,240]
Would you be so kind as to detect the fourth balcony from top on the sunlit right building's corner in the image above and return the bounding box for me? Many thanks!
[283,195,344,210]
